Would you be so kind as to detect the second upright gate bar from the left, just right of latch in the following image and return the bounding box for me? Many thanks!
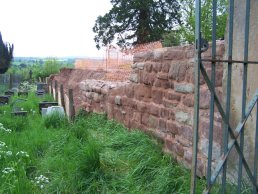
[207,0,217,187]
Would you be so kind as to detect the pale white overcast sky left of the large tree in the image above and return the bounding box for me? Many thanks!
[0,0,112,57]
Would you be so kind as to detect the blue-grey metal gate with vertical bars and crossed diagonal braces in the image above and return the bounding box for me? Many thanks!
[191,0,258,194]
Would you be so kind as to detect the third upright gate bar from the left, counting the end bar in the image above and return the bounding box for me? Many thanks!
[221,0,234,194]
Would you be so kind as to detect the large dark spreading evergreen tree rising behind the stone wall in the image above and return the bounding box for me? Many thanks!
[93,0,181,49]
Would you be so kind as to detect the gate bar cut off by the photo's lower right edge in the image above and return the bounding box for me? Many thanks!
[253,101,258,194]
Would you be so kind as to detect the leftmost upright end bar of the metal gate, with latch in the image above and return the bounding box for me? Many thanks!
[190,0,201,194]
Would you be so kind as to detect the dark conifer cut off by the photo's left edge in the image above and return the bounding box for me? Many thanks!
[0,32,13,74]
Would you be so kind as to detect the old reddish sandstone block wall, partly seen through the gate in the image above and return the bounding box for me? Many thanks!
[72,42,224,176]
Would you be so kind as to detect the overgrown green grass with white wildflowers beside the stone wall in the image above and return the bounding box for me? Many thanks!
[0,94,208,194]
